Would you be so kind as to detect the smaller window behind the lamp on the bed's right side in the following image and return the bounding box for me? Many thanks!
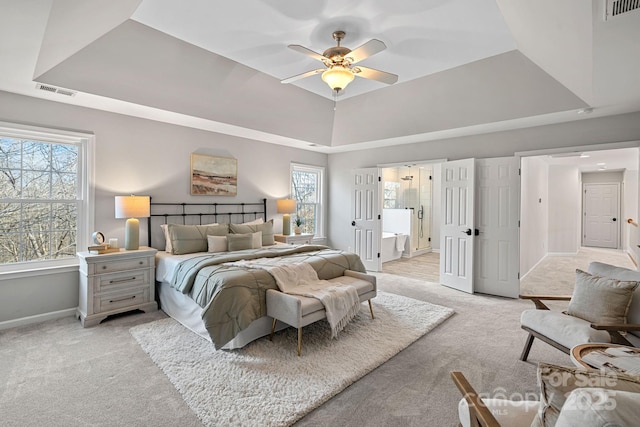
[291,164,324,237]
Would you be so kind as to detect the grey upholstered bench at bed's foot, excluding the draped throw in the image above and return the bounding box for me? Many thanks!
[267,270,377,356]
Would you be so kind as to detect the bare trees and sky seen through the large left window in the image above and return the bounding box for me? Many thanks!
[0,136,79,264]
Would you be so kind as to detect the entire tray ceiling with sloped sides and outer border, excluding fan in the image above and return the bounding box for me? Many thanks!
[0,0,640,157]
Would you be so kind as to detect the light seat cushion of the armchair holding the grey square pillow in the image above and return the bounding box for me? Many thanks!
[520,309,611,348]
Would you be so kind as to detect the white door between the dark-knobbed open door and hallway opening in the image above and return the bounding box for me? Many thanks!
[474,157,520,298]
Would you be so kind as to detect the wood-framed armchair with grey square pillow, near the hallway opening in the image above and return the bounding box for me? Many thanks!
[520,262,640,361]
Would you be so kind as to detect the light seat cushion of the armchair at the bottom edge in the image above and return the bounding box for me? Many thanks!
[458,397,540,427]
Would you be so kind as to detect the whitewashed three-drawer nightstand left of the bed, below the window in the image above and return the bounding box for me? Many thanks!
[76,247,158,328]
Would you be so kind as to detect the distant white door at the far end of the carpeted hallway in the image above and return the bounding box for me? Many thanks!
[582,183,620,248]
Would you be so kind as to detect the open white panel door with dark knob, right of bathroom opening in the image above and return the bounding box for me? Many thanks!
[440,159,475,293]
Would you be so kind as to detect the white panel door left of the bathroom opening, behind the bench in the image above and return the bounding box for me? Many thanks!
[351,168,382,271]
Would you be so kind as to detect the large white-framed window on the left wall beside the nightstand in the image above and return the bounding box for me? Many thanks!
[0,123,92,271]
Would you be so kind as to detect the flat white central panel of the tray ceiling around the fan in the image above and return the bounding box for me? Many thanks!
[131,0,516,99]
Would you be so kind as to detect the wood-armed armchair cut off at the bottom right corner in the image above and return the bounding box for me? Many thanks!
[451,363,640,427]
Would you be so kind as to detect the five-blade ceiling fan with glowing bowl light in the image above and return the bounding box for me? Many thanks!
[281,31,398,95]
